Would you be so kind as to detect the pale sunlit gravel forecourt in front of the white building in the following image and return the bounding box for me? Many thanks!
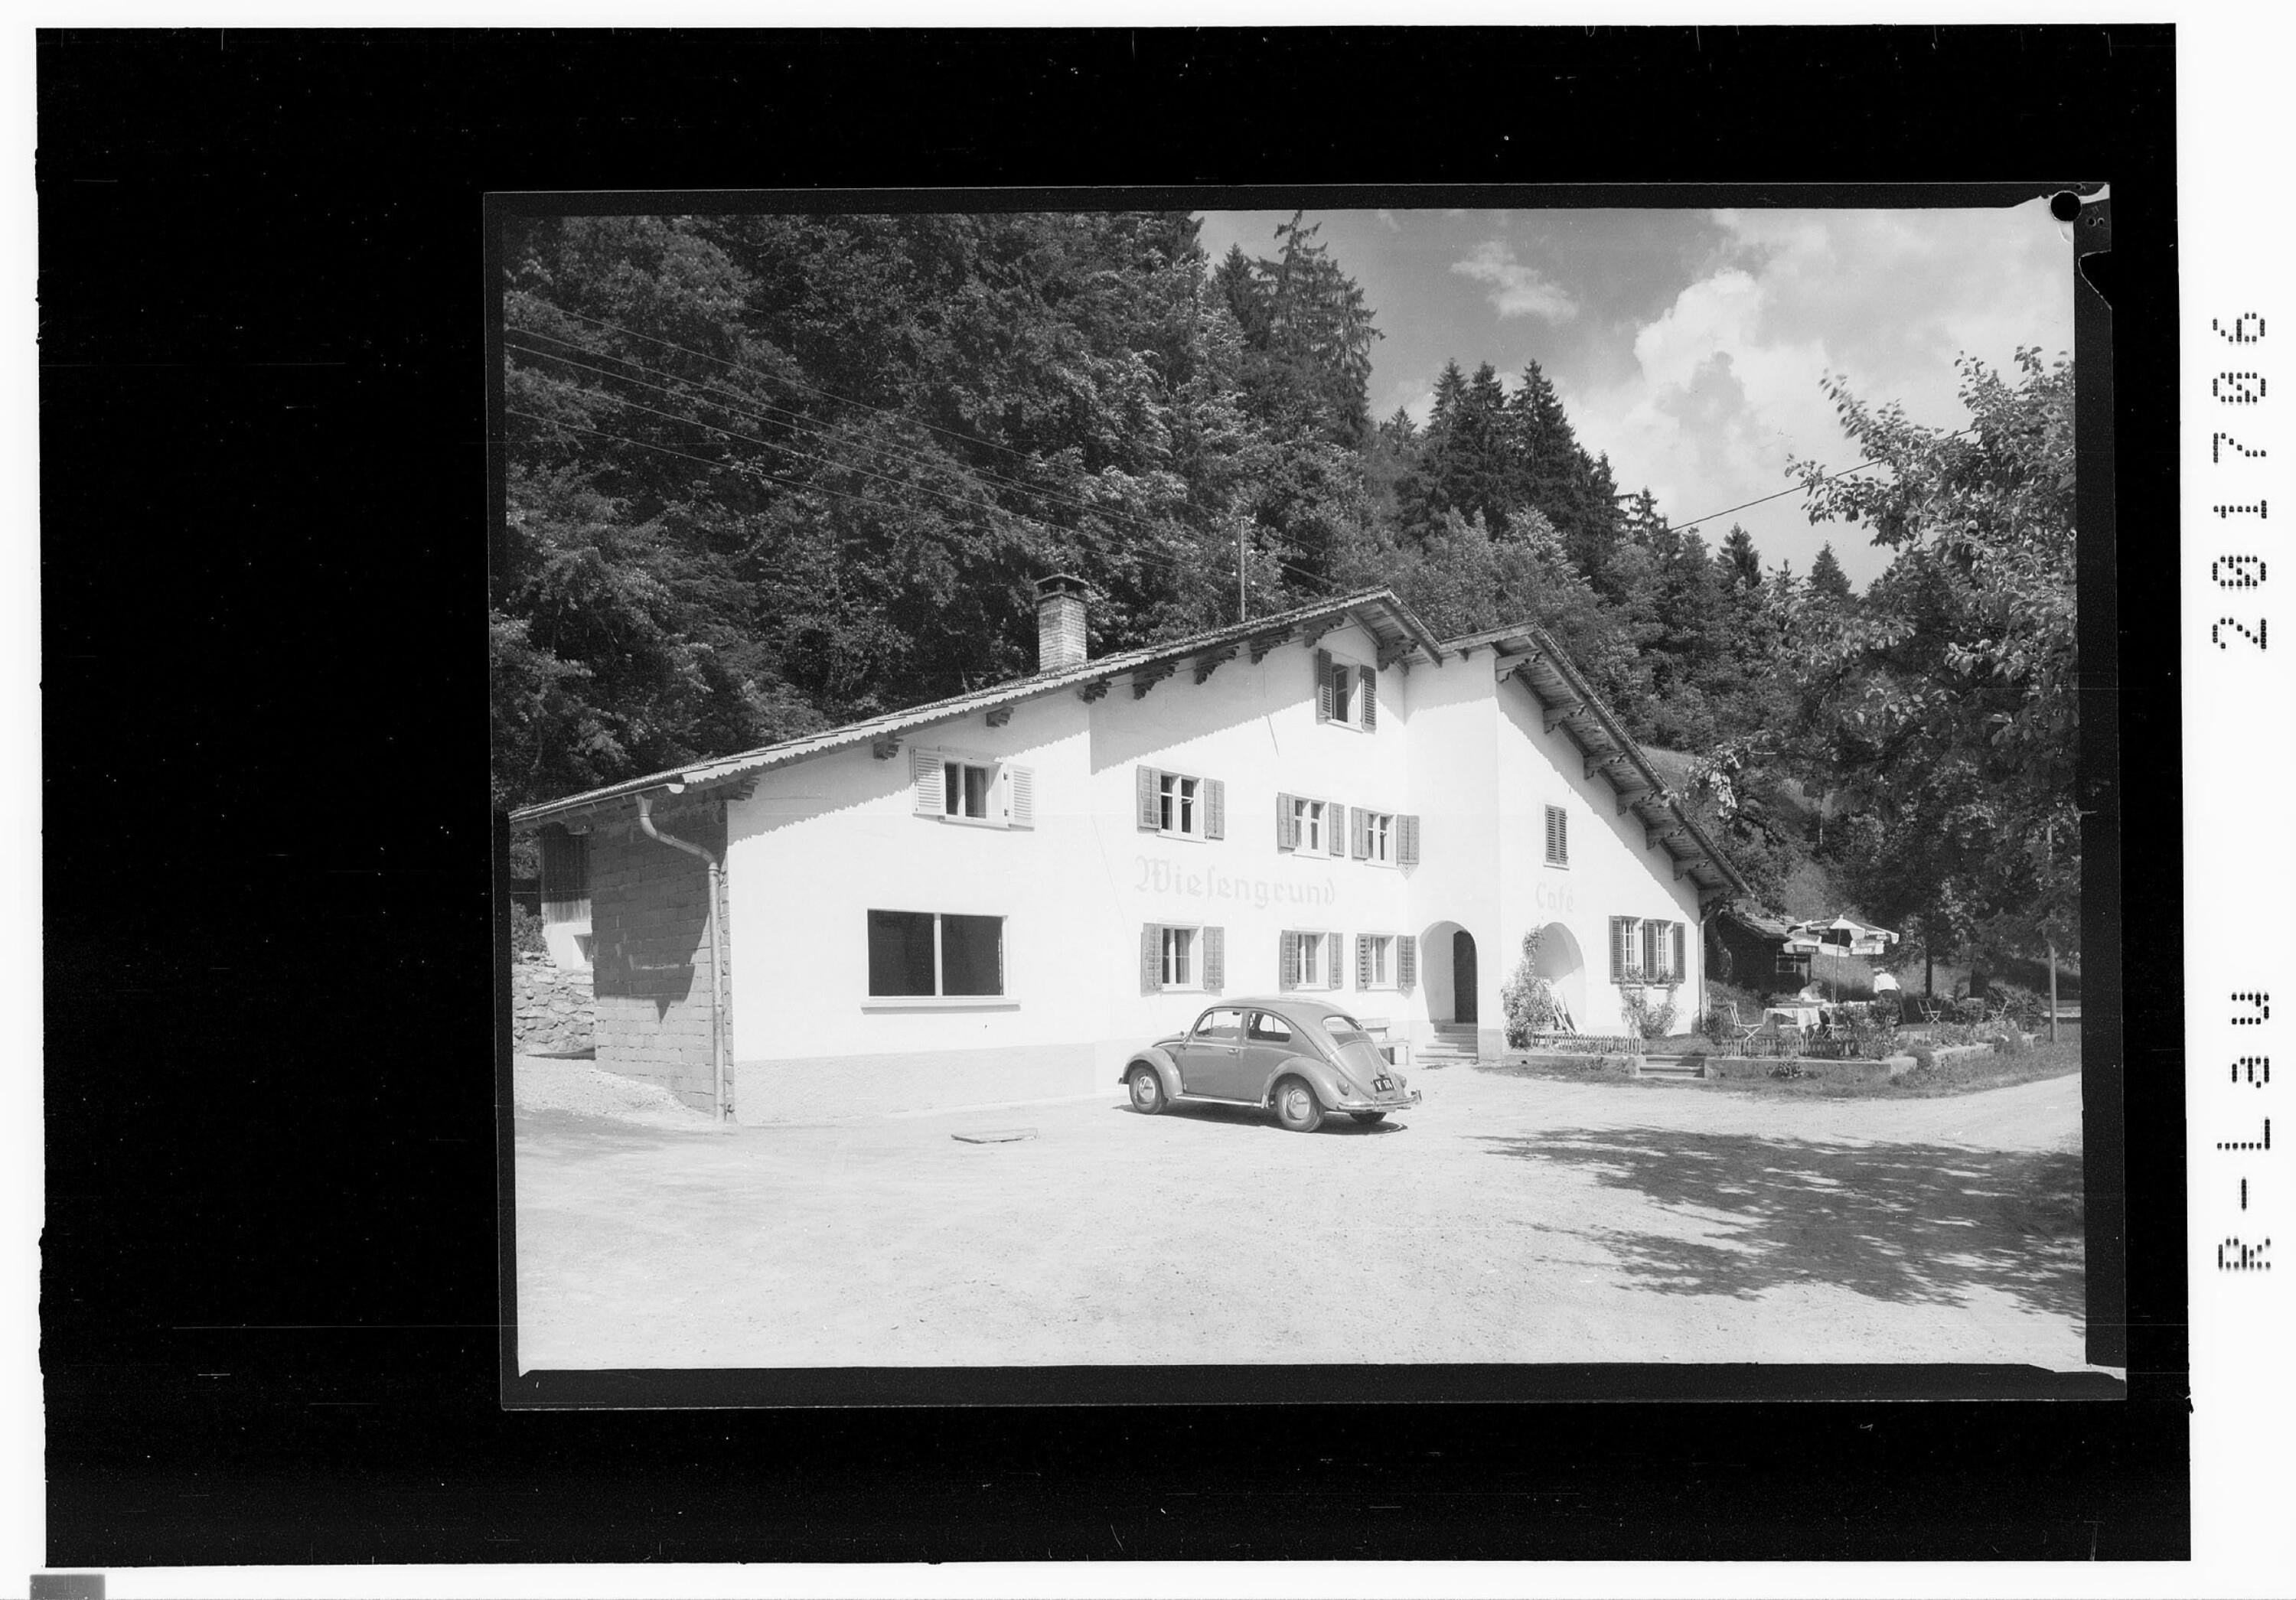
[514,1058,2085,1370]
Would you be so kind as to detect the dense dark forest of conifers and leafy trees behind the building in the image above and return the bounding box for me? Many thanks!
[489,211,2080,978]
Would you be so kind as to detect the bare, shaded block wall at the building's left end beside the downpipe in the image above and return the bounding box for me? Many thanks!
[590,803,732,1111]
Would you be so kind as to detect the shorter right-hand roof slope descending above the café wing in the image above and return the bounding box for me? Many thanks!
[1442,622,1754,898]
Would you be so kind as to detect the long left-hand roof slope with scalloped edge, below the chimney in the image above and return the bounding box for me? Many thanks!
[510,588,1442,829]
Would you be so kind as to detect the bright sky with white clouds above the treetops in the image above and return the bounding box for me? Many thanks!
[1201,200,2073,588]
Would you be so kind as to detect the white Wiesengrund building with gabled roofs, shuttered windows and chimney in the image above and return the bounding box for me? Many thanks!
[512,578,1745,1123]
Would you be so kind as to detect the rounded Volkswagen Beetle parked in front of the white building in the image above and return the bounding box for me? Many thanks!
[1118,994,1419,1134]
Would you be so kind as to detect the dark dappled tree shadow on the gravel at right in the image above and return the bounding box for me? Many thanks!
[1483,1129,2082,1318]
